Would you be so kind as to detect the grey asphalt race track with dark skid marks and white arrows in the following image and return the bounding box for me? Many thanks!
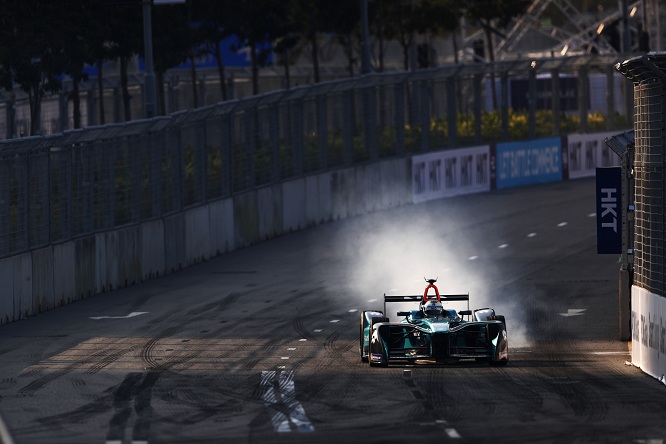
[0,179,666,444]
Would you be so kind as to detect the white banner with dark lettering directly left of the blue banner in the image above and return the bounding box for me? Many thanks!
[412,145,490,203]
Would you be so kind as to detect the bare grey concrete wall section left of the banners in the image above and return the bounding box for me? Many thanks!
[0,159,412,324]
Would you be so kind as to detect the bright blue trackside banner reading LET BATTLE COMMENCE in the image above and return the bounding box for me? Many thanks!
[494,137,562,189]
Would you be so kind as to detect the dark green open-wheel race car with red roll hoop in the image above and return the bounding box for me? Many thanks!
[360,279,509,366]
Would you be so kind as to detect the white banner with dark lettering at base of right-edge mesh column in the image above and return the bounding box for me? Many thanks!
[631,286,666,383]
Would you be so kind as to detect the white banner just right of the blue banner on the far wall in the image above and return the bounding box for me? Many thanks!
[565,131,621,179]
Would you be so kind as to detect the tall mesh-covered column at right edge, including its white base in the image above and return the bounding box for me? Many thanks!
[617,52,666,380]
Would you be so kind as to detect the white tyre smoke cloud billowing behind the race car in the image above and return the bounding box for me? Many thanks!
[337,205,528,347]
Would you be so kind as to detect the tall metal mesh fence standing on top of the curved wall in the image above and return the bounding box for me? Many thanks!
[0,57,633,257]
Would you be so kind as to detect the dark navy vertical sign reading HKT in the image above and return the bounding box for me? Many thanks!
[597,167,622,254]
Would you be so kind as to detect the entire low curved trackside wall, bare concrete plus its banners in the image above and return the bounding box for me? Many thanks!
[0,133,619,324]
